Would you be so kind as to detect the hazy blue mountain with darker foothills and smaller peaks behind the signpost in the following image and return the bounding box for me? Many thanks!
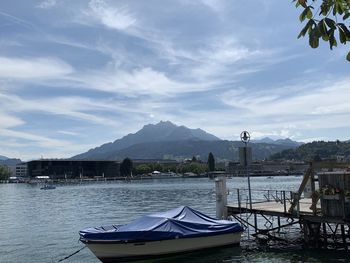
[72,121,294,161]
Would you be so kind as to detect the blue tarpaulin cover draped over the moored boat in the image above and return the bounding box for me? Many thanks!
[79,206,243,242]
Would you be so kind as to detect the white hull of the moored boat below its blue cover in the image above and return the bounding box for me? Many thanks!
[84,232,242,262]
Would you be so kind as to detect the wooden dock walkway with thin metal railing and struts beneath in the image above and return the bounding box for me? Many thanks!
[226,189,350,250]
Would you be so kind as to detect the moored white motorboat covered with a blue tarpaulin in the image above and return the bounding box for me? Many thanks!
[79,206,243,262]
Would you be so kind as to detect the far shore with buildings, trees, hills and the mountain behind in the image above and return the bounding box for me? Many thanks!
[0,121,350,182]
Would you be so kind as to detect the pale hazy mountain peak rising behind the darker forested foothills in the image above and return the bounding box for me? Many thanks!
[72,121,220,159]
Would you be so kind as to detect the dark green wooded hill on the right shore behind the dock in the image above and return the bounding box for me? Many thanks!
[270,141,350,161]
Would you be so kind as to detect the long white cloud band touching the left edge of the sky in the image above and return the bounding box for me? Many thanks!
[0,57,73,80]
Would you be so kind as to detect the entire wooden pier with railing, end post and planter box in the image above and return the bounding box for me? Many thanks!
[216,165,350,251]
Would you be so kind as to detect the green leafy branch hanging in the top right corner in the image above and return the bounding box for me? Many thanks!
[293,0,350,61]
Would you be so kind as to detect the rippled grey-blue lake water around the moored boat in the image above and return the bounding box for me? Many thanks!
[0,177,350,263]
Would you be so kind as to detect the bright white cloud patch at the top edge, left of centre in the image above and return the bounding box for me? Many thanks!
[86,0,136,30]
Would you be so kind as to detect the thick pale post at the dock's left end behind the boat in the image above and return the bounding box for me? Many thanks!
[215,176,227,219]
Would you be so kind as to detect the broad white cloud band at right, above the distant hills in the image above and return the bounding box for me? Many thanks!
[222,78,350,117]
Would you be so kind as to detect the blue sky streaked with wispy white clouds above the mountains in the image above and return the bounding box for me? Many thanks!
[0,0,350,160]
